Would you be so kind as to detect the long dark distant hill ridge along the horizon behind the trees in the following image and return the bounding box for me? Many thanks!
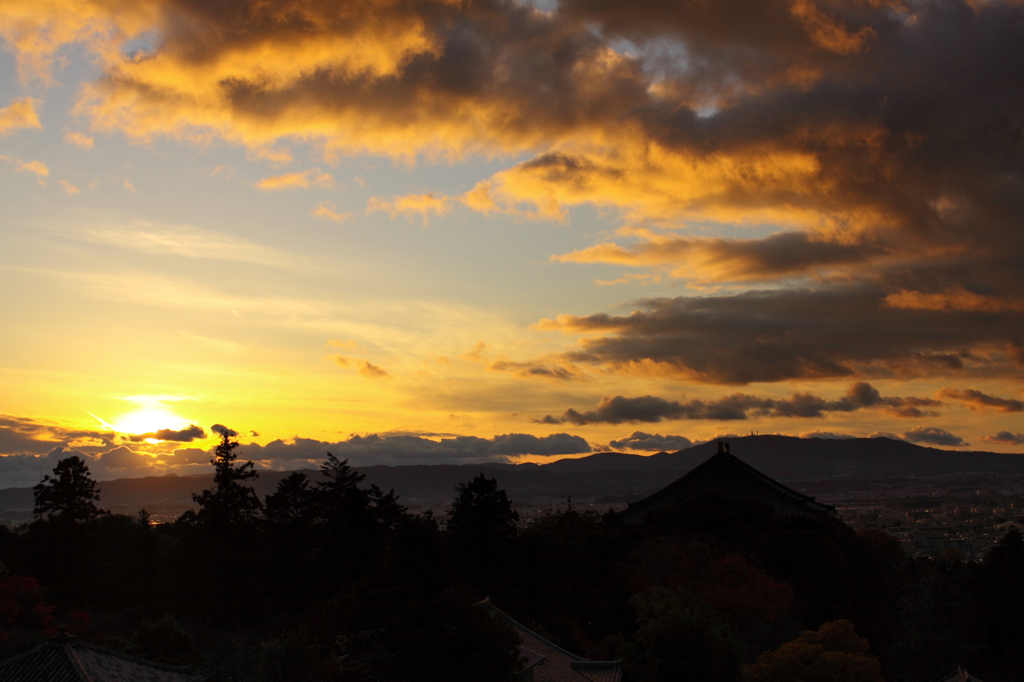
[0,435,1024,510]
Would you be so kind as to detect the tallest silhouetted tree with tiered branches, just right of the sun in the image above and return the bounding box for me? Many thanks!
[193,430,262,532]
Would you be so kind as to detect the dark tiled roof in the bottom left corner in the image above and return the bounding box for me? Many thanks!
[0,635,210,682]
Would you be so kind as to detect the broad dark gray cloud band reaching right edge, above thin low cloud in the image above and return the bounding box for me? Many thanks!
[540,286,1024,384]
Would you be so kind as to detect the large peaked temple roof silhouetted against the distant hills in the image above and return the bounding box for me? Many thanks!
[620,440,837,523]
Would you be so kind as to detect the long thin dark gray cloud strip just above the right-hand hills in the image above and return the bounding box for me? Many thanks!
[534,382,942,426]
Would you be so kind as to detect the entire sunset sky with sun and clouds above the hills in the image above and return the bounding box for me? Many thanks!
[0,0,1024,487]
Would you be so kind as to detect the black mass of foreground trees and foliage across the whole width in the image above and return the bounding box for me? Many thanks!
[0,436,1024,682]
